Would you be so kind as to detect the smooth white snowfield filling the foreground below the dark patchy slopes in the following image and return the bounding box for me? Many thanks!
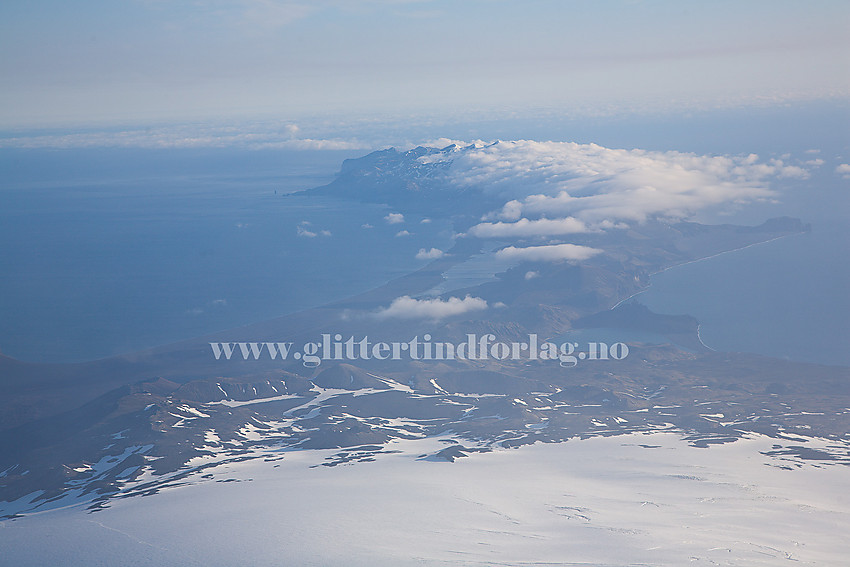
[0,432,850,567]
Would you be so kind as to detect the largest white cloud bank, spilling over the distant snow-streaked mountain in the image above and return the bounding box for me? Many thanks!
[420,140,808,227]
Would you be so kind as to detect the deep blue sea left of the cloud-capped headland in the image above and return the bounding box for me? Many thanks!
[0,149,451,361]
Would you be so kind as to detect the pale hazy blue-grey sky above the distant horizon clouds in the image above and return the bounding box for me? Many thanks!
[0,0,850,127]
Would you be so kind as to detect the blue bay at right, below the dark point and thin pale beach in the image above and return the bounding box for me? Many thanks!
[636,223,850,365]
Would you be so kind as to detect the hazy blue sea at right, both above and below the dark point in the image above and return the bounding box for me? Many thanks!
[635,153,850,366]
